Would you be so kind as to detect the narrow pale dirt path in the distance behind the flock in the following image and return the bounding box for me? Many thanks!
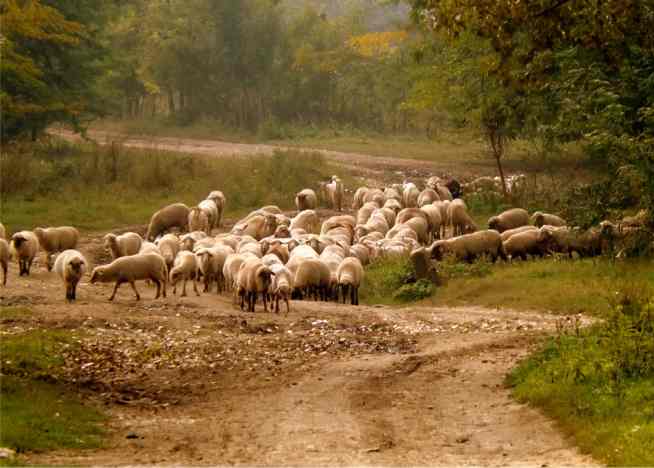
[50,129,472,183]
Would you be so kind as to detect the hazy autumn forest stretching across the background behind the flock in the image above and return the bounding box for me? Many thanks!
[0,0,654,218]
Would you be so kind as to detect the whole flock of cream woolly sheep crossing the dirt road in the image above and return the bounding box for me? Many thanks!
[0,176,615,312]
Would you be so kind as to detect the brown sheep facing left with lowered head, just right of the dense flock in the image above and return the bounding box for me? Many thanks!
[430,230,506,263]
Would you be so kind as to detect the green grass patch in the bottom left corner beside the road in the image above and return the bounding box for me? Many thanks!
[0,328,106,456]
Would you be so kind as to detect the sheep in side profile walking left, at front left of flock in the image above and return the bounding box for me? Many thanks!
[91,253,168,301]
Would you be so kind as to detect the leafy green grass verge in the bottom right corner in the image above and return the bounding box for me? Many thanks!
[508,290,654,466]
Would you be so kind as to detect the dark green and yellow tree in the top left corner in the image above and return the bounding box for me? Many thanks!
[0,0,110,142]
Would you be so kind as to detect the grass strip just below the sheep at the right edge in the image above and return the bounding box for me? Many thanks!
[431,258,654,316]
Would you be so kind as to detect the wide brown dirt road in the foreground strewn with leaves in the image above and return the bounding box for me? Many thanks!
[0,229,592,466]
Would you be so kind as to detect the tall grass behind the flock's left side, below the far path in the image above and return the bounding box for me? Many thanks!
[0,140,350,232]
